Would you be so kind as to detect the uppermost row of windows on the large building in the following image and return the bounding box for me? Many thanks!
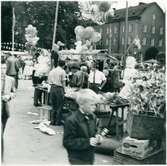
[104,24,164,35]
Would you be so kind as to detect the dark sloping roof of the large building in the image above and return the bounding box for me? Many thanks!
[107,2,158,23]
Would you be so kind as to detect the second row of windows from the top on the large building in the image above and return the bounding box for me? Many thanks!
[106,37,163,47]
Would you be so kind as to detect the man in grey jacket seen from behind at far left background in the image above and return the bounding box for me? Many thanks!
[6,53,19,88]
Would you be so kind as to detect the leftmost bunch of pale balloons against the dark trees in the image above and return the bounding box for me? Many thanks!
[25,25,39,46]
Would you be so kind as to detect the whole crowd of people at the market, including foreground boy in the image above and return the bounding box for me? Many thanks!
[1,49,165,164]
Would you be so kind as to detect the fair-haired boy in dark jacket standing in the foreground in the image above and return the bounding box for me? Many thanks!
[63,89,102,165]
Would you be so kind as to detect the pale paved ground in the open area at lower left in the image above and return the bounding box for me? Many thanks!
[4,80,115,165]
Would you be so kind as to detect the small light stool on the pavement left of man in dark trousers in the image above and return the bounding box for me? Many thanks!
[38,105,52,121]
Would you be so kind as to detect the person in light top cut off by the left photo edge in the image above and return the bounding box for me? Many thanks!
[1,58,15,162]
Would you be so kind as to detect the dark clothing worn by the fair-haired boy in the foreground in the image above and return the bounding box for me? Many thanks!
[63,110,97,165]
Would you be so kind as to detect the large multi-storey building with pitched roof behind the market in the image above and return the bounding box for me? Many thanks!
[95,2,165,61]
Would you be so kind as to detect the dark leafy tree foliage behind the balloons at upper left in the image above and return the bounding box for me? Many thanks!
[2,1,96,48]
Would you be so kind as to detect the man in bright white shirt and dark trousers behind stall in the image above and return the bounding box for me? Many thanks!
[88,64,106,93]
